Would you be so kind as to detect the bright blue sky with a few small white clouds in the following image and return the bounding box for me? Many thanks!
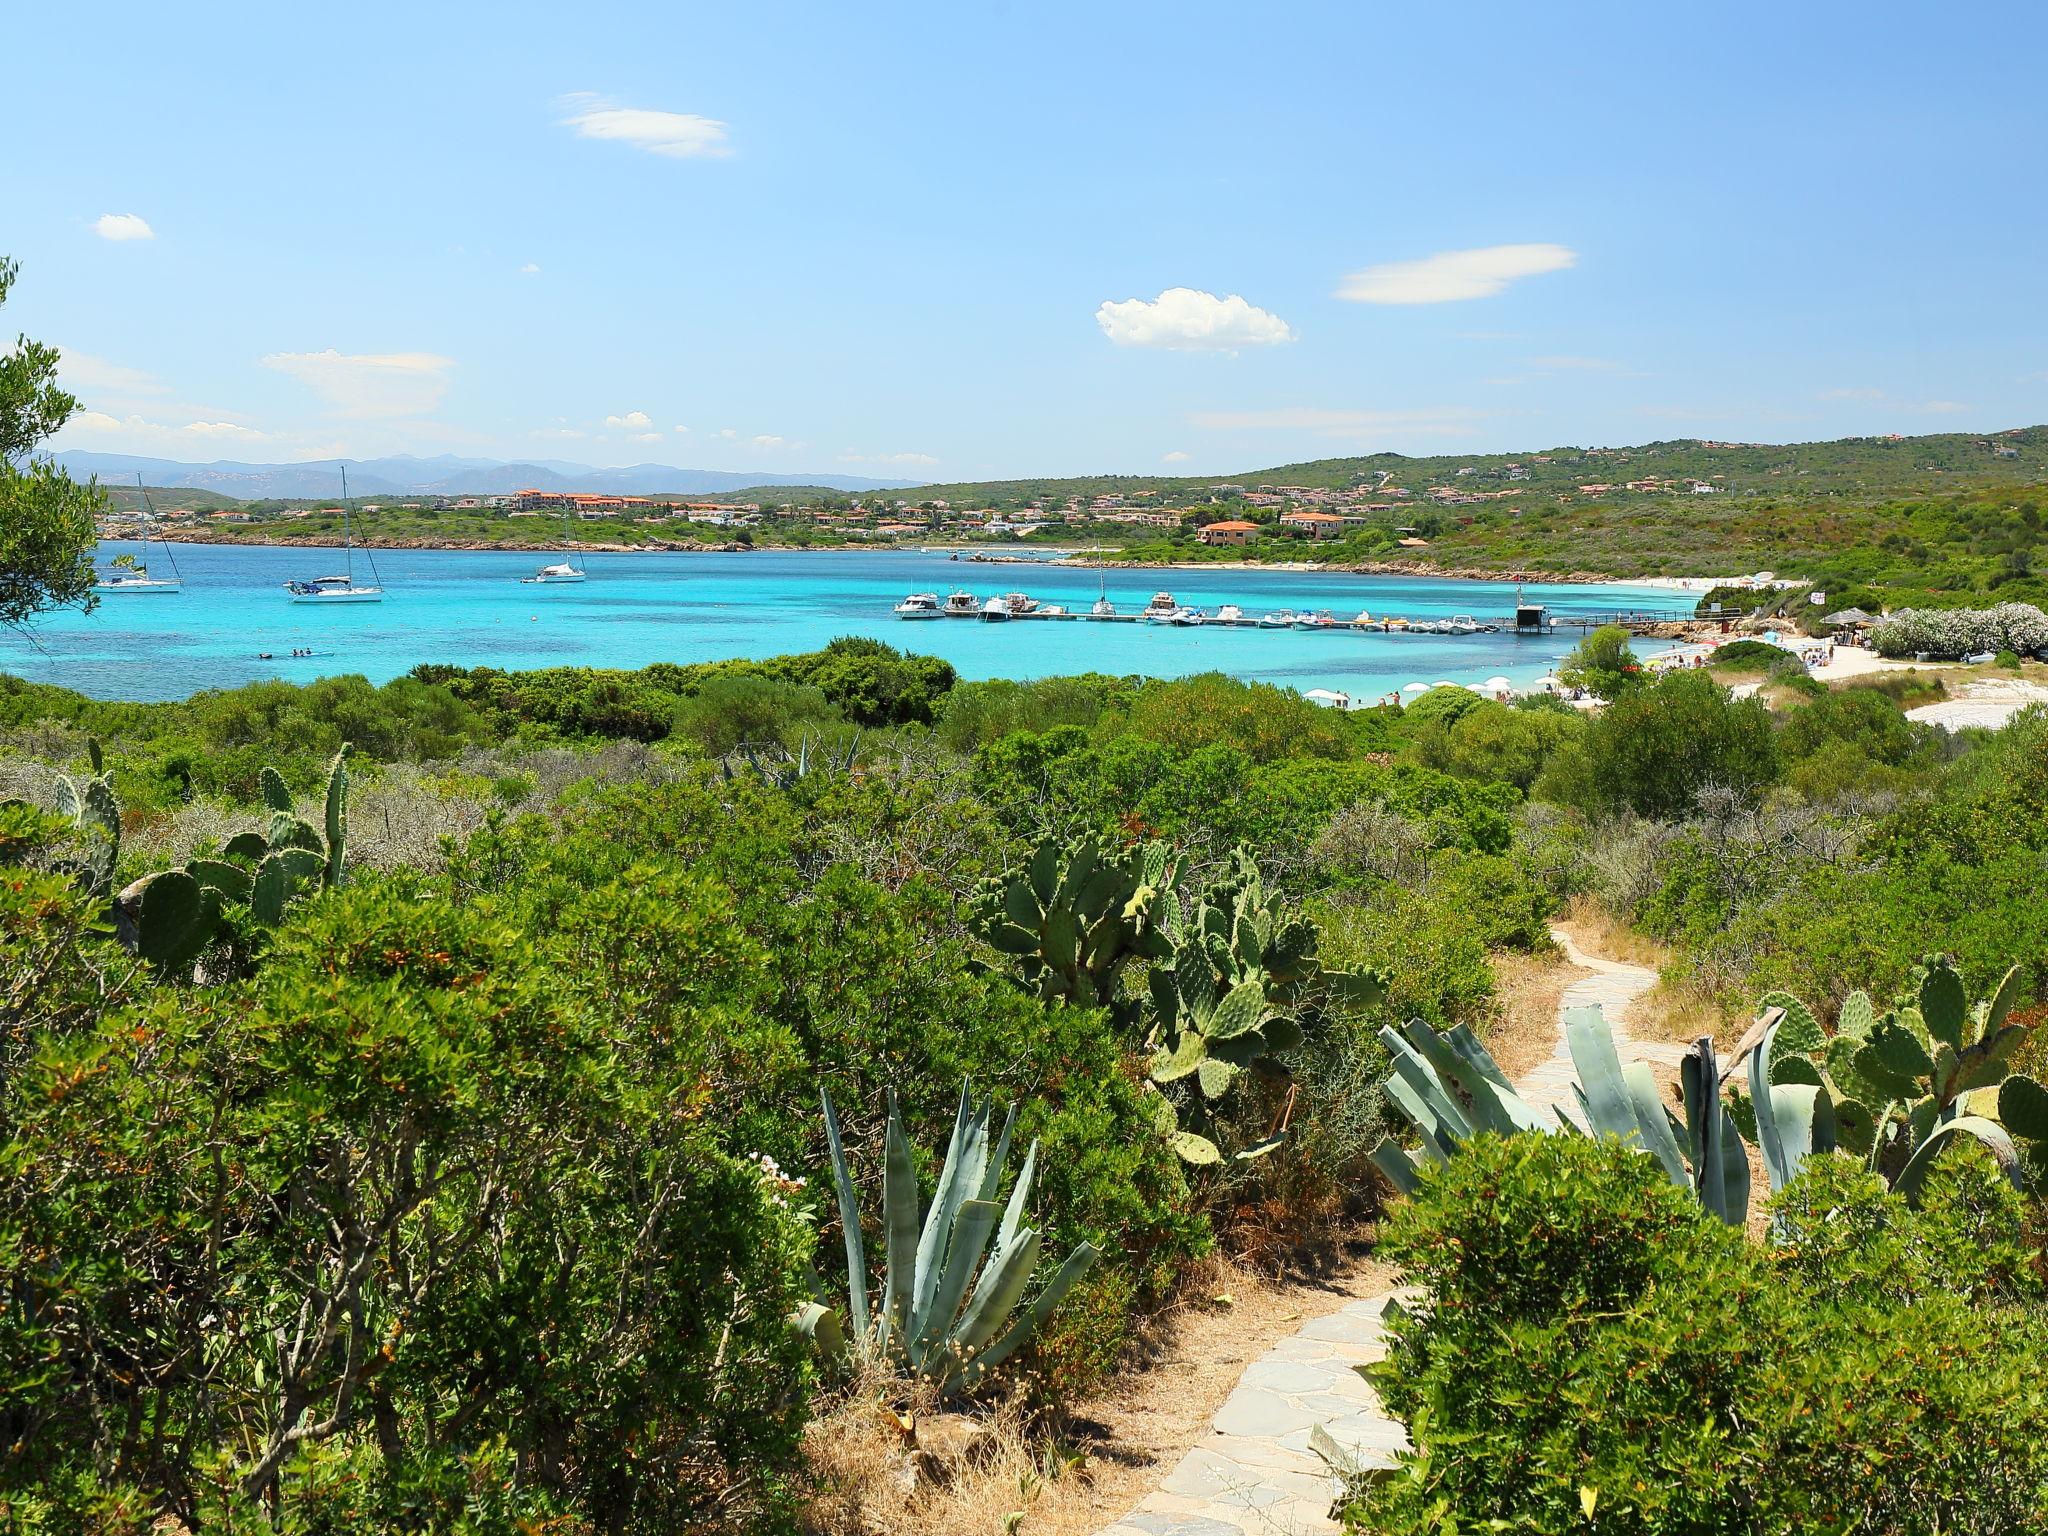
[0,2,2048,479]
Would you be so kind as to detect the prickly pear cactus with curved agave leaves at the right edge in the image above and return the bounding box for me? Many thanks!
[1735,956,2048,1200]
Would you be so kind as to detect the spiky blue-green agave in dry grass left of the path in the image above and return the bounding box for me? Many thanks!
[819,1087,1100,1397]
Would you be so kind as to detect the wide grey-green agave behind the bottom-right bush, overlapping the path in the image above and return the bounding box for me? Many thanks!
[1372,1006,1749,1227]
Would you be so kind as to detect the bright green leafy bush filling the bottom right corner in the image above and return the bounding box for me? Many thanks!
[1348,1137,2048,1536]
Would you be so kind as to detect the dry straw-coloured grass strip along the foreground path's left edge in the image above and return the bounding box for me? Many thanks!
[805,1243,1391,1536]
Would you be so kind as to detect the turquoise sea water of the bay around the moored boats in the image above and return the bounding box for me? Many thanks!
[0,543,1673,698]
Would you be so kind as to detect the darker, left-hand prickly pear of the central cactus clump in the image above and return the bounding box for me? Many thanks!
[969,838,1178,1032]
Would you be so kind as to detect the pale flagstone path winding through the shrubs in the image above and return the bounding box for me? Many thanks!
[1100,928,1683,1536]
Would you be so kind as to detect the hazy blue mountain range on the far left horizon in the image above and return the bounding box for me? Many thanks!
[49,451,920,502]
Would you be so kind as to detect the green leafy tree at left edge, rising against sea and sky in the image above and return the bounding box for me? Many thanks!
[0,260,100,625]
